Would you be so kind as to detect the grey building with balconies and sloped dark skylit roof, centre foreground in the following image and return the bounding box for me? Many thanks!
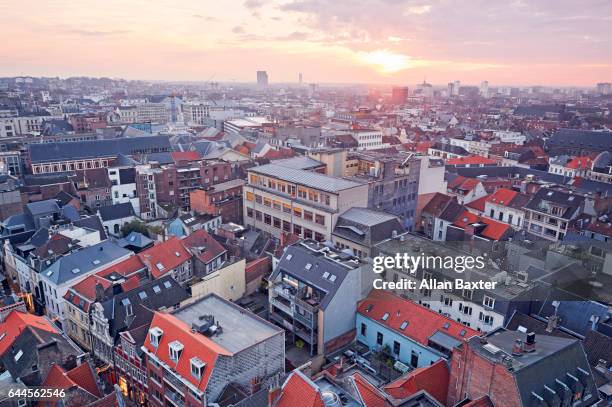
[268,240,371,355]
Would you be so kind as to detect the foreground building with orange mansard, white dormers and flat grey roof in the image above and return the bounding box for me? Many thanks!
[142,294,285,407]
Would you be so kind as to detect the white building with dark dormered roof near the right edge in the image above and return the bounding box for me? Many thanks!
[525,188,585,241]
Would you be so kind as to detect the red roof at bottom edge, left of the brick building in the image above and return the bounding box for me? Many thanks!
[385,359,450,405]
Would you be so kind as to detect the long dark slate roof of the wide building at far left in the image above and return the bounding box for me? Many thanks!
[28,136,170,163]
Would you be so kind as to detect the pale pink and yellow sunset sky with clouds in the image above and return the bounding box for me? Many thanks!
[0,0,612,86]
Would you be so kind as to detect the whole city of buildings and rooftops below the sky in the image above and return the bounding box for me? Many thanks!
[0,71,612,407]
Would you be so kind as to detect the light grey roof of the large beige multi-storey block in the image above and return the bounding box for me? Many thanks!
[249,164,363,193]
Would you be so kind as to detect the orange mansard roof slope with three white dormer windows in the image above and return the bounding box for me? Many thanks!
[144,312,231,391]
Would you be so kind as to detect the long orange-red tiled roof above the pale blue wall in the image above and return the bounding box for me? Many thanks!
[357,290,479,345]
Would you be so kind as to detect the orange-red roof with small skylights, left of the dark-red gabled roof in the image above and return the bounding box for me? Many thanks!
[138,236,191,278]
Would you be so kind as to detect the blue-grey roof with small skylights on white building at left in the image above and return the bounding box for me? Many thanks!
[41,240,132,285]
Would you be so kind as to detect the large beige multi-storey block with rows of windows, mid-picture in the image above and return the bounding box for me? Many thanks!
[243,164,368,241]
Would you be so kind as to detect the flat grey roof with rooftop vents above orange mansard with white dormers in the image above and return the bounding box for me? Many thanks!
[172,295,282,353]
